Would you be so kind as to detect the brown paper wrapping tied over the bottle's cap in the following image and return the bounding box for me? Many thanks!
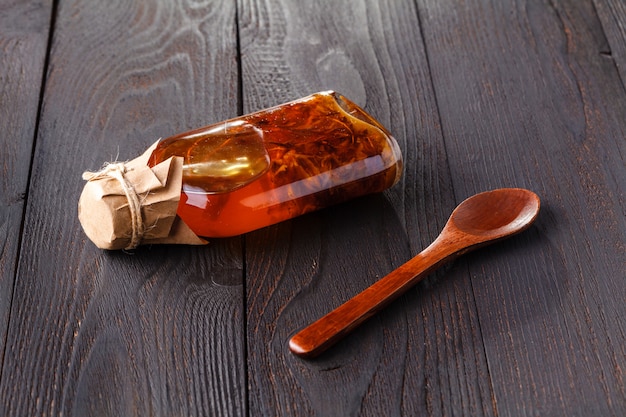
[78,142,207,249]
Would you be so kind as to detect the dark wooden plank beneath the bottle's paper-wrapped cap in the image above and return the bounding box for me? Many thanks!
[0,0,246,416]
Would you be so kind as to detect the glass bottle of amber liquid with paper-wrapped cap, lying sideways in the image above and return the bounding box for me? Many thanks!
[78,92,402,249]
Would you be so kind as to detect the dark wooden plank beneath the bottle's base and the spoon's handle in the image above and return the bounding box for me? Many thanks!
[240,1,494,416]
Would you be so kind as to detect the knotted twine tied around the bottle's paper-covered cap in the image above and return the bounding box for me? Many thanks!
[83,162,145,250]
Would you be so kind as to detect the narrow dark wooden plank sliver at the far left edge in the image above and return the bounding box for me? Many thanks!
[0,1,52,368]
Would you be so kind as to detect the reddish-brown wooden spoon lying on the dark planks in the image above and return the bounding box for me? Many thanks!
[289,188,539,358]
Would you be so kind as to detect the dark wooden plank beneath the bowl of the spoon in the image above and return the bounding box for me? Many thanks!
[419,0,626,416]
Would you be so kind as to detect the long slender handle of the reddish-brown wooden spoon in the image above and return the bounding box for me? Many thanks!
[289,236,459,358]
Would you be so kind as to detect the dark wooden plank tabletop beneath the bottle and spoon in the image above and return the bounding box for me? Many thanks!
[0,0,626,416]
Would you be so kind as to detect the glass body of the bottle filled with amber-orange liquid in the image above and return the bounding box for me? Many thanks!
[149,92,402,237]
